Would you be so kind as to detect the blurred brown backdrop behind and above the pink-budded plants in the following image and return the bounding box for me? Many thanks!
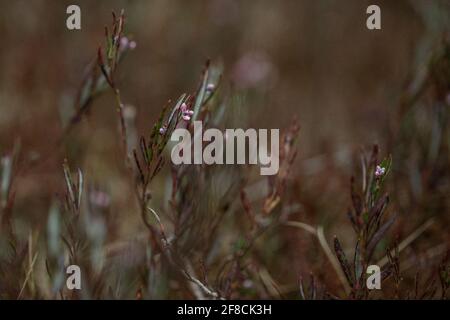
[0,0,450,300]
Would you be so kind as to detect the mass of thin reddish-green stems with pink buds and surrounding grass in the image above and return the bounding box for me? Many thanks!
[0,11,450,299]
